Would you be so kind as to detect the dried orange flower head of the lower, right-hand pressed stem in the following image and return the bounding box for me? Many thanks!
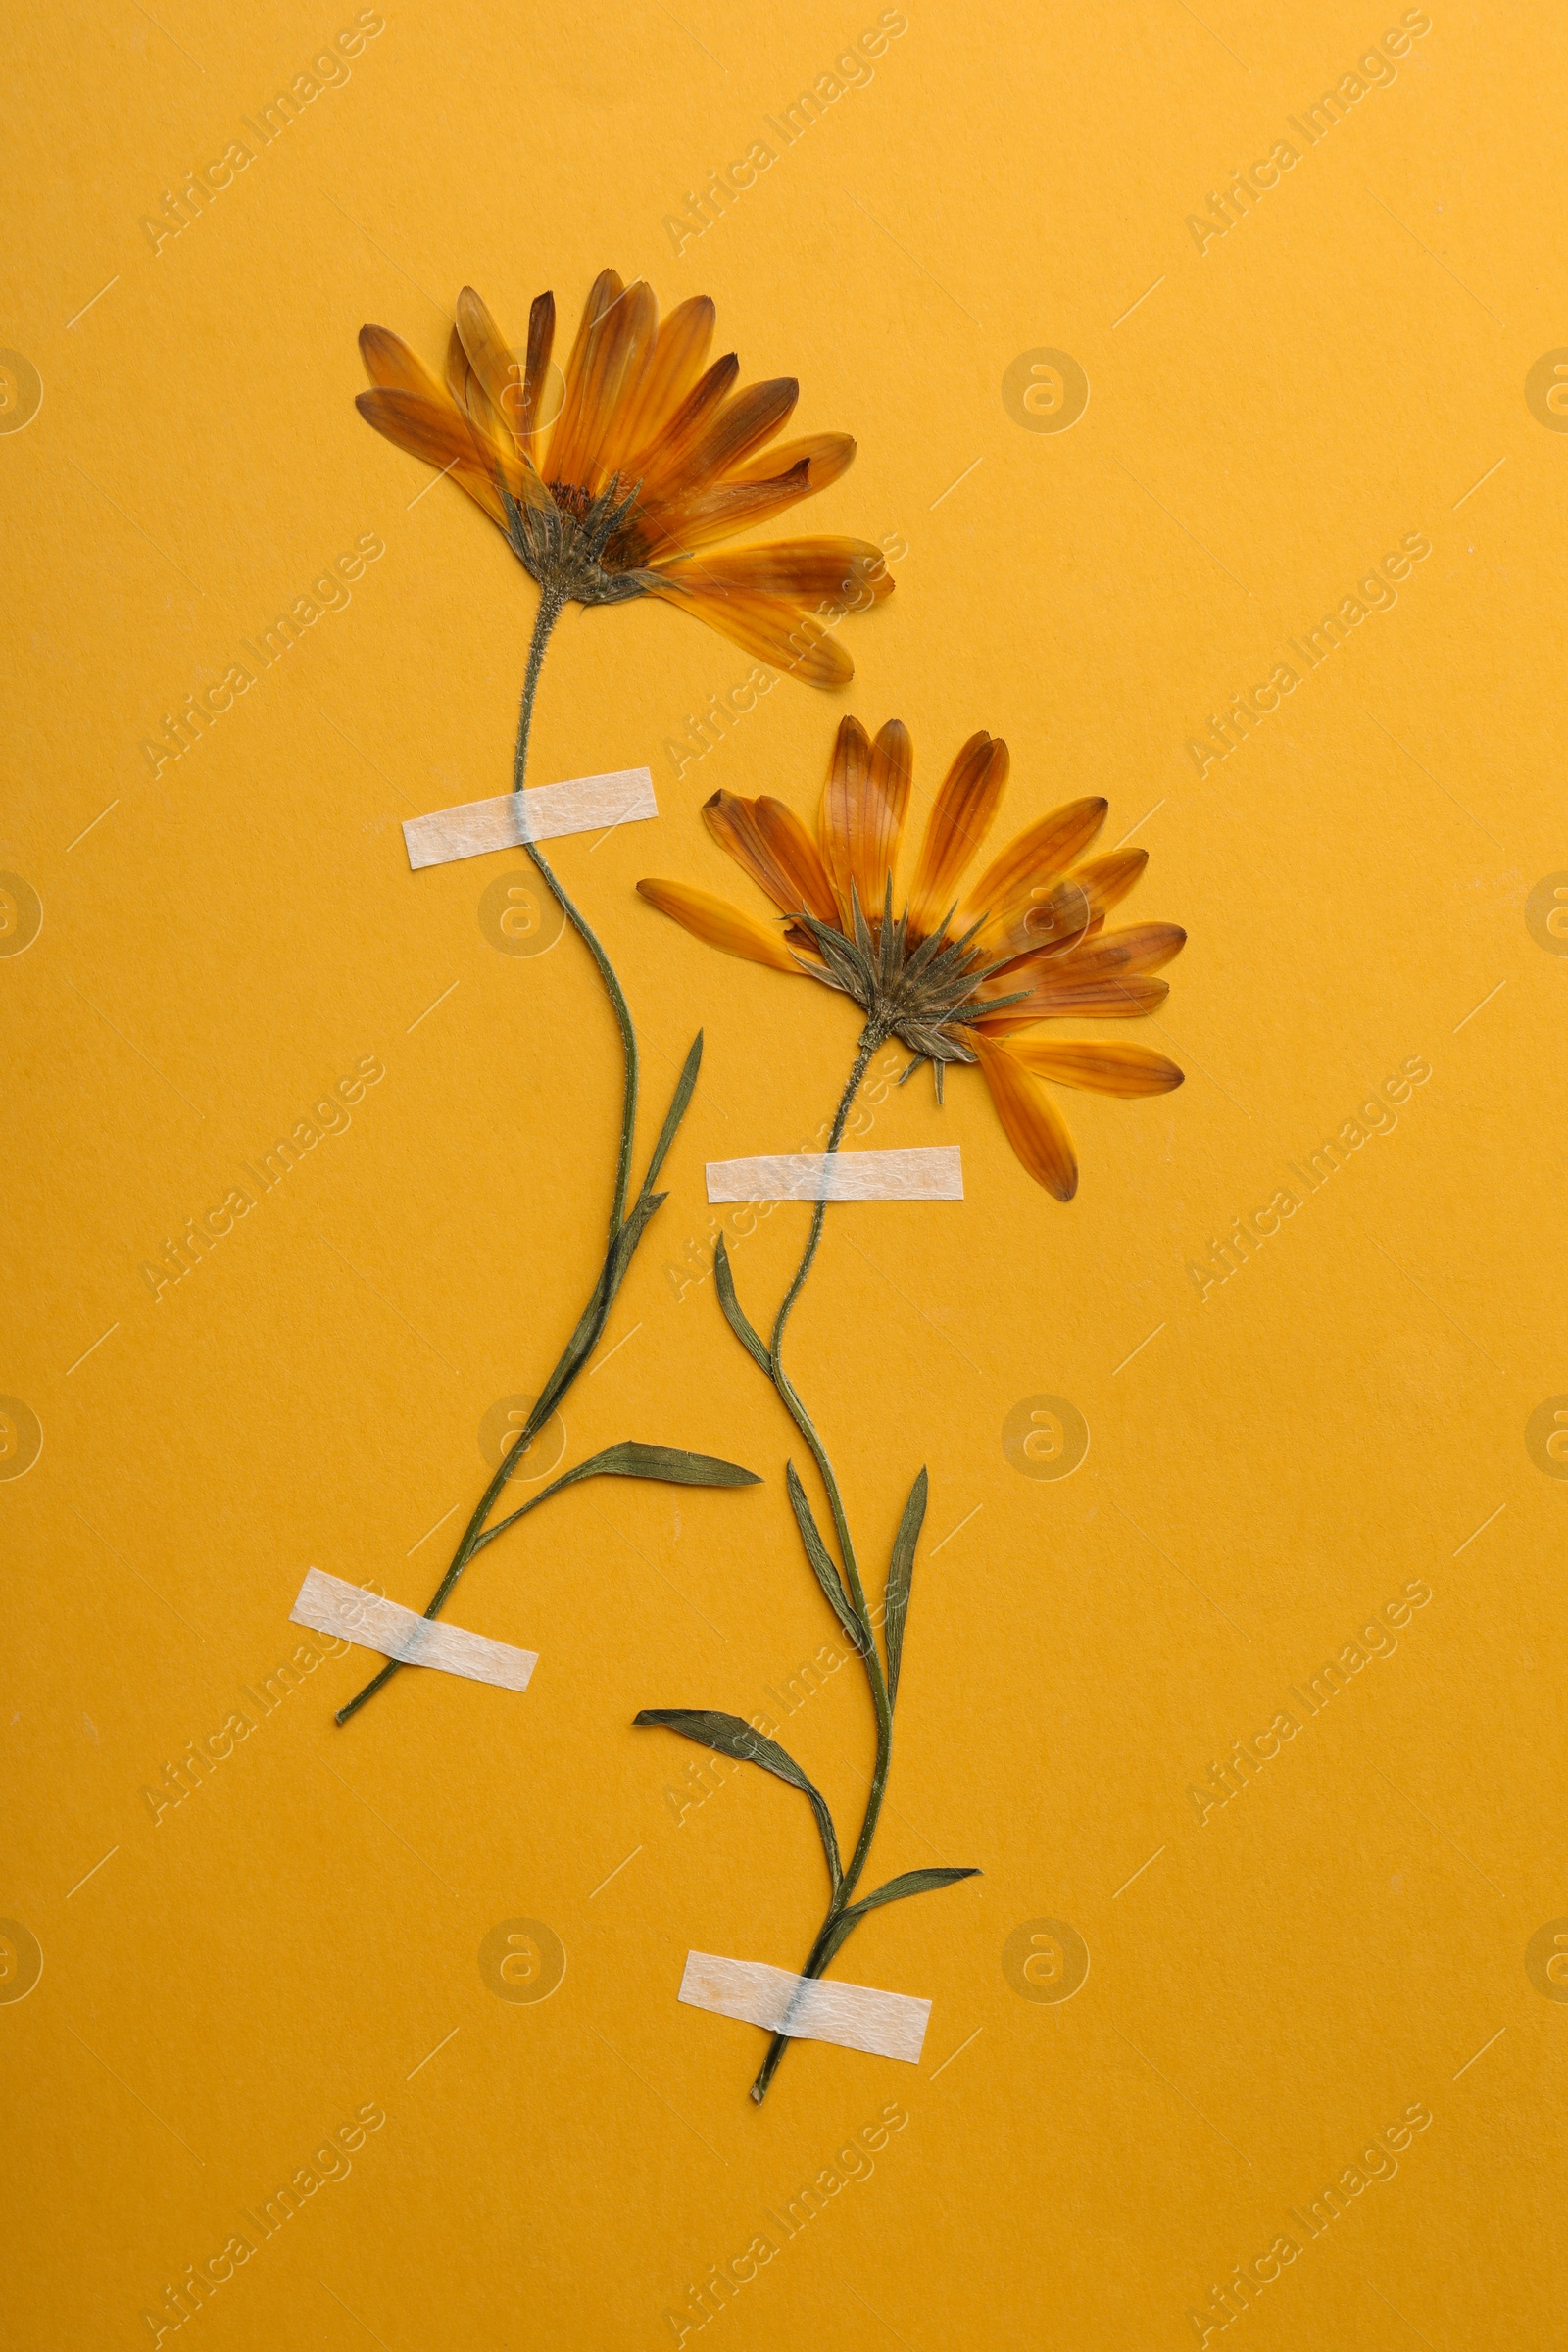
[637,717,1187,1200]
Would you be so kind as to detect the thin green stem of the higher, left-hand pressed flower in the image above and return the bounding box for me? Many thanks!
[336,590,658,1724]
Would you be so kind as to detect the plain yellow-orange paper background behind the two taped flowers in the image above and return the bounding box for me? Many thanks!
[0,0,1568,2352]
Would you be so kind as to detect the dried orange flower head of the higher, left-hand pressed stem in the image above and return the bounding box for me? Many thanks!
[358,270,894,687]
